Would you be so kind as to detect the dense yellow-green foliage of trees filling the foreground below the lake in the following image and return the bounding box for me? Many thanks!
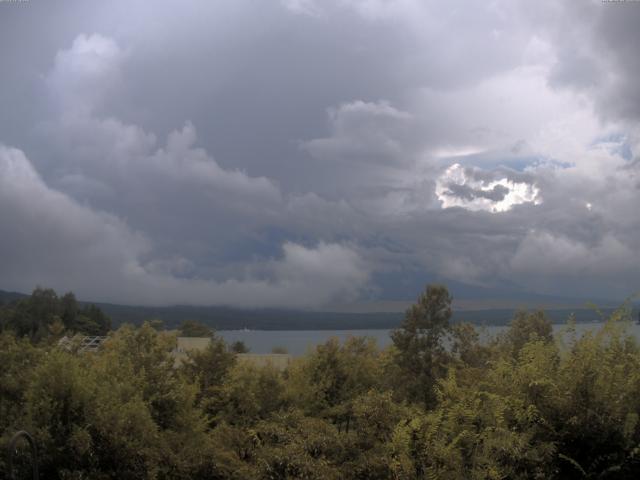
[0,286,640,480]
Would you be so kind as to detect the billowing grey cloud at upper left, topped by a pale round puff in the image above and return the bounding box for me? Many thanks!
[41,35,282,274]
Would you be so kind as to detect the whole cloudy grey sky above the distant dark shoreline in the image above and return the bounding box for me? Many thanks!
[0,0,640,309]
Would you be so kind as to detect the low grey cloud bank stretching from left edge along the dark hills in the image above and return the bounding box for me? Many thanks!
[0,145,368,307]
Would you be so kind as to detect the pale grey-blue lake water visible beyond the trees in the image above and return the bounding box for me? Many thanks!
[217,323,640,355]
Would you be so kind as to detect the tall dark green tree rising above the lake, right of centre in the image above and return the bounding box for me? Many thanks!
[391,285,452,407]
